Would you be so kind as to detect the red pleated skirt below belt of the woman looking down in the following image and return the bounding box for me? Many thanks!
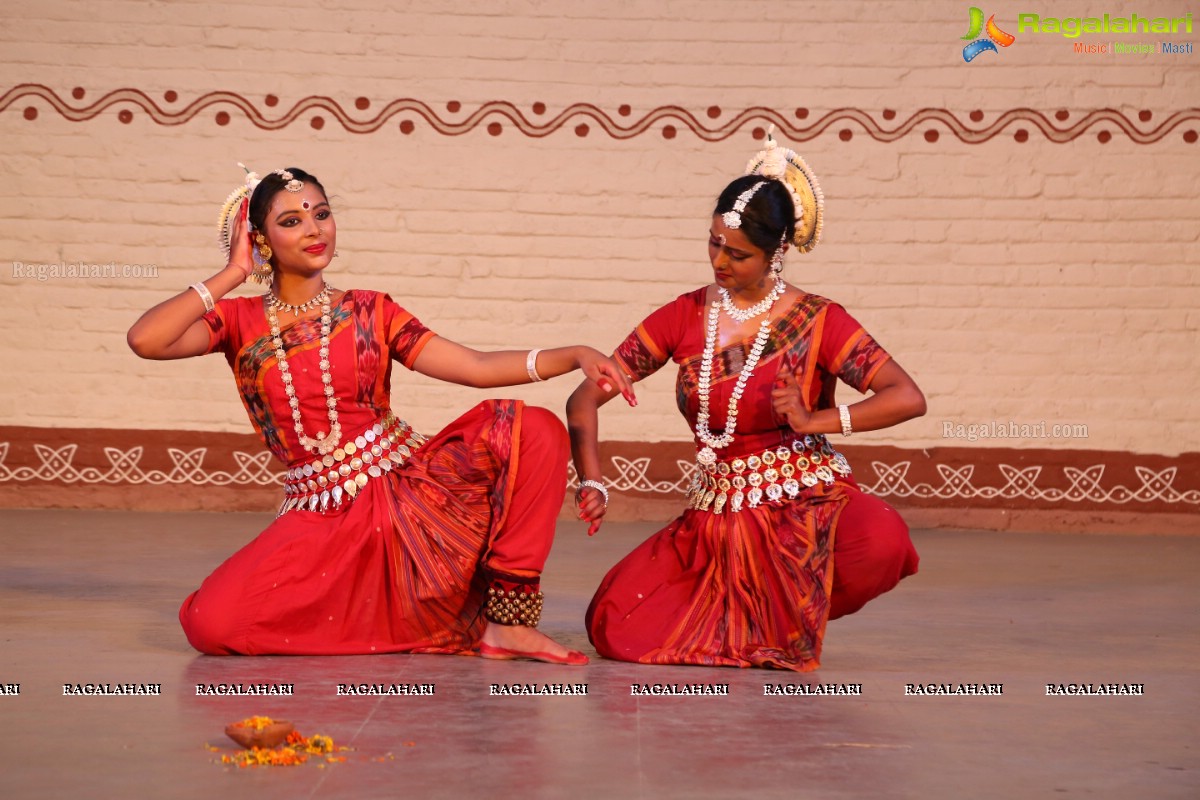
[587,482,918,672]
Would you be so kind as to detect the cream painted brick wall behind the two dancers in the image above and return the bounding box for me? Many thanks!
[0,0,1200,453]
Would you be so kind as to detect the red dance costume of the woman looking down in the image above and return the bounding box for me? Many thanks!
[587,289,918,672]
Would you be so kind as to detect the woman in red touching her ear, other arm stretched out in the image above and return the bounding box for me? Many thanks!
[128,168,634,664]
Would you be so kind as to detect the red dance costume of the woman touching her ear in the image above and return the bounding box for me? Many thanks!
[179,290,568,655]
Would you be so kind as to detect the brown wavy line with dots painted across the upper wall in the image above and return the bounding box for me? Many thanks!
[0,84,1200,144]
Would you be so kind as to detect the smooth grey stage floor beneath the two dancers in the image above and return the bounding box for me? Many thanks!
[0,511,1200,799]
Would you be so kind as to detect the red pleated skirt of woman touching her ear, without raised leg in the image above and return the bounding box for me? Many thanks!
[179,401,528,655]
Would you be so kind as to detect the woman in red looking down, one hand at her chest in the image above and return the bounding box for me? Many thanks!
[568,134,925,672]
